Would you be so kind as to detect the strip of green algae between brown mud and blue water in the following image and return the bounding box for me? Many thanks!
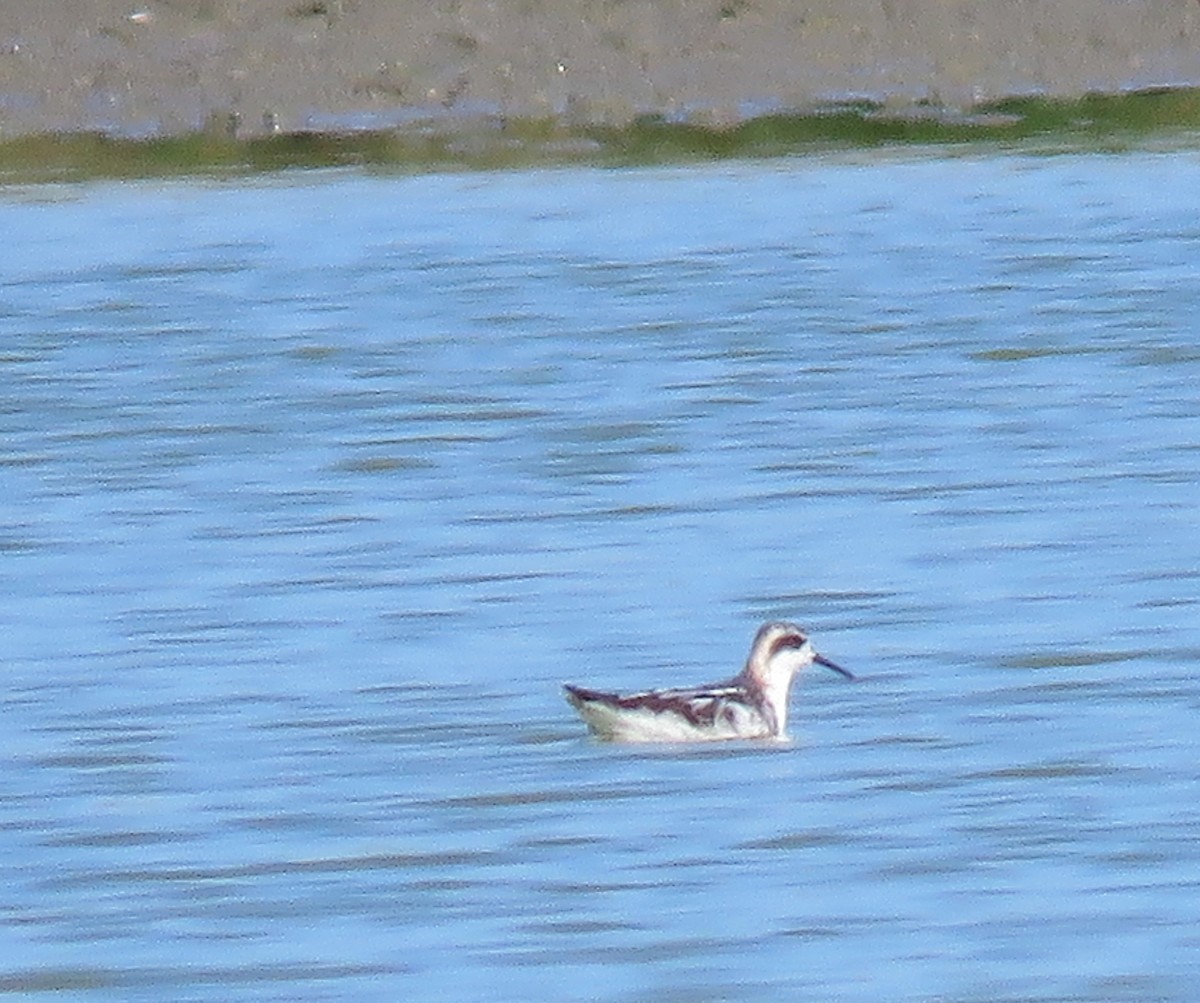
[7,88,1200,184]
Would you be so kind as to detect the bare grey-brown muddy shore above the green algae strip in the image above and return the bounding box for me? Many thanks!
[0,0,1200,138]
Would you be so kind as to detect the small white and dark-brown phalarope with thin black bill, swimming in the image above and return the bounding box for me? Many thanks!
[563,623,854,741]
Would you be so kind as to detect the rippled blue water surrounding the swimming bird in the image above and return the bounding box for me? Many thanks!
[0,149,1200,1003]
